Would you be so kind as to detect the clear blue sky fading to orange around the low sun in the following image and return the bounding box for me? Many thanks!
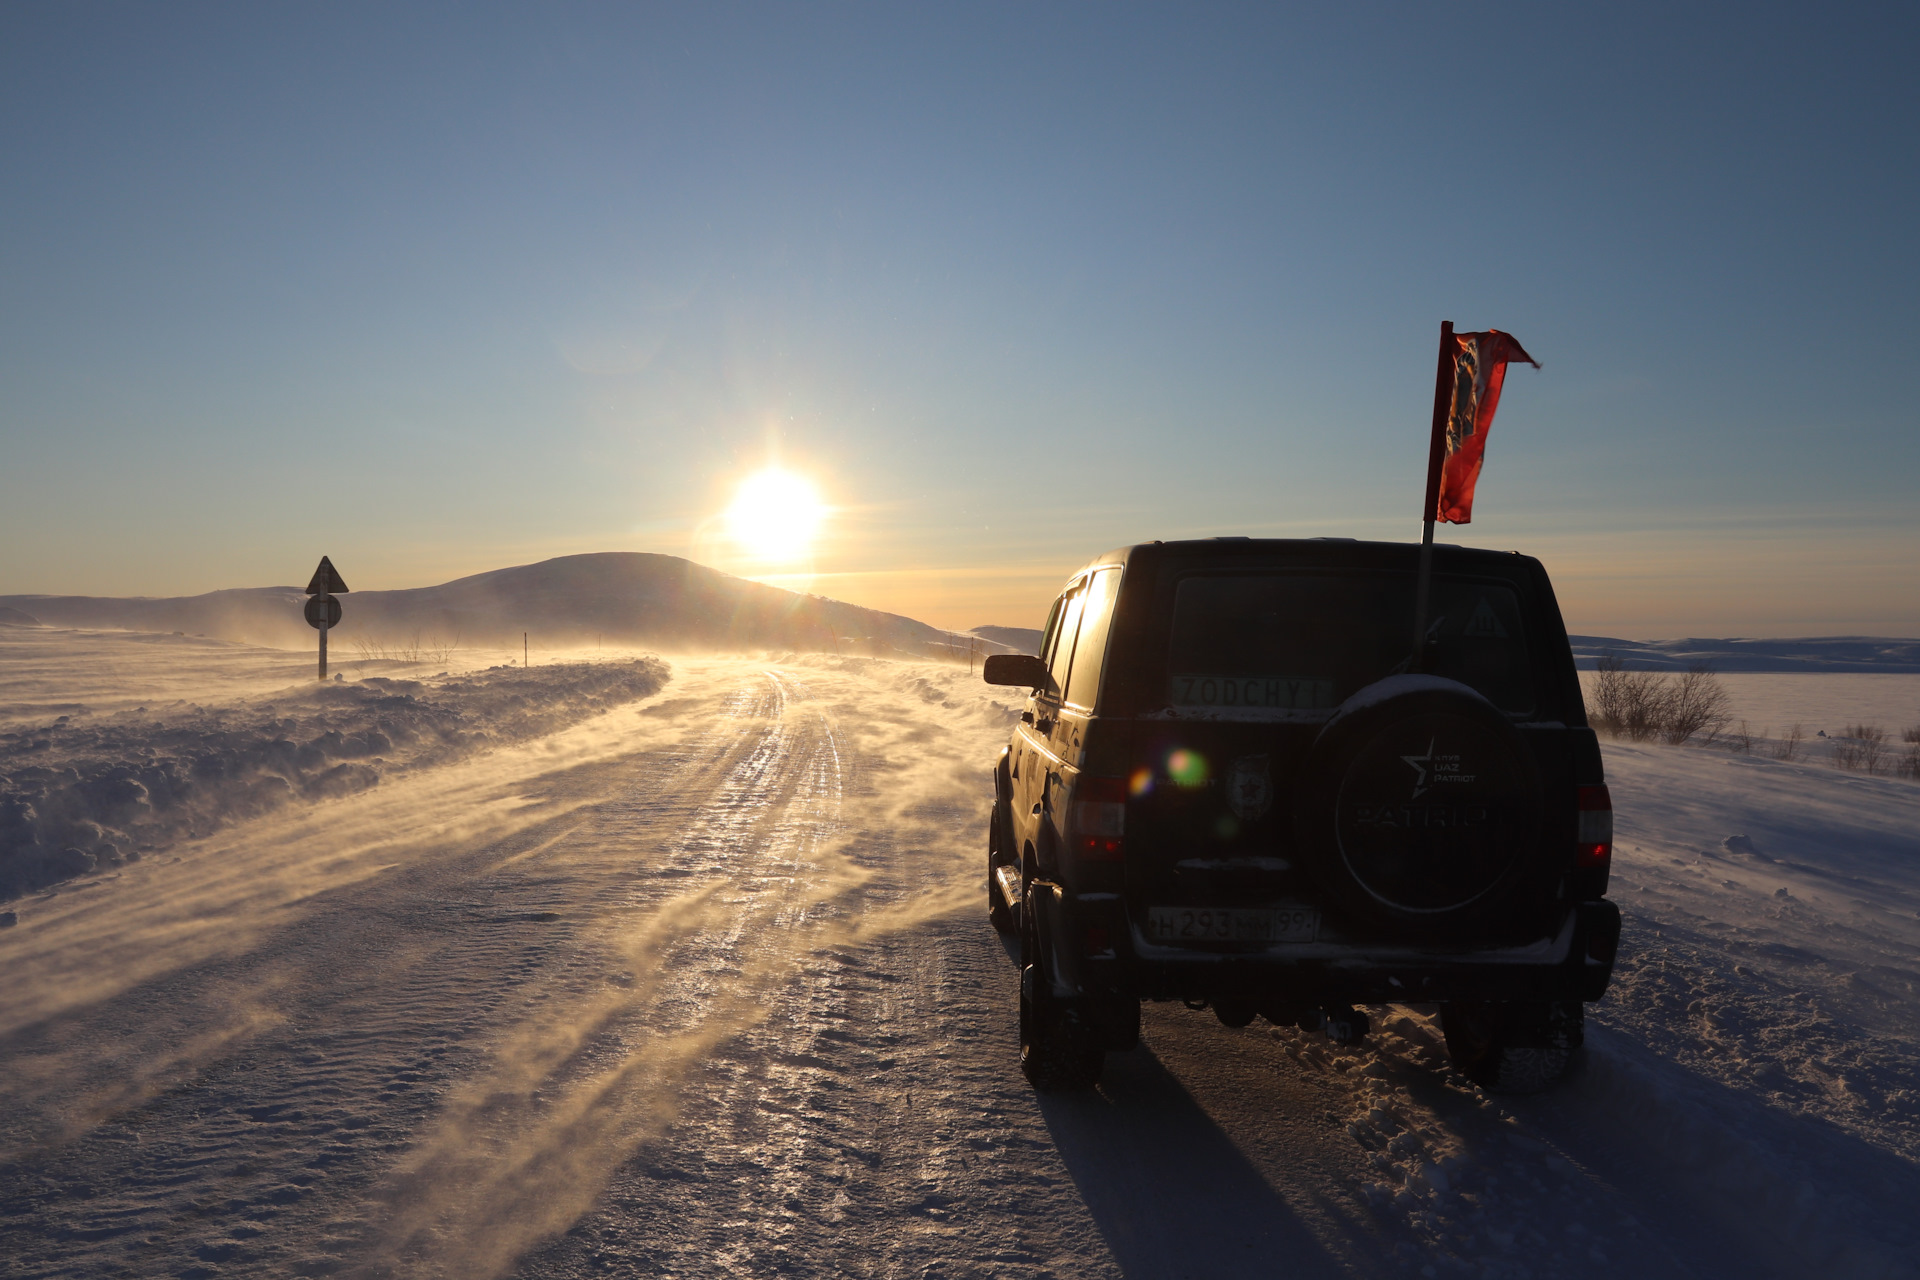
[0,4,1920,637]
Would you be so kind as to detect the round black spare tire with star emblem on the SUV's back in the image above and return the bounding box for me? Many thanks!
[1294,676,1540,935]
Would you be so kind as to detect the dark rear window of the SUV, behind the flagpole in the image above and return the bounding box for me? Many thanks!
[1167,574,1534,714]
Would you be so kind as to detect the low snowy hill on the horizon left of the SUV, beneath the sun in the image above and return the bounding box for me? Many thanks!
[0,551,1036,658]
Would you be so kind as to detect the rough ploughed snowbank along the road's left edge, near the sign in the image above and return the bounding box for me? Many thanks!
[0,658,668,900]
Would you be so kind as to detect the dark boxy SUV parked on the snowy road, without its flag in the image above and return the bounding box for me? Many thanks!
[985,537,1620,1090]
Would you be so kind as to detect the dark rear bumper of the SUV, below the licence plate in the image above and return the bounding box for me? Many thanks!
[1035,889,1620,1007]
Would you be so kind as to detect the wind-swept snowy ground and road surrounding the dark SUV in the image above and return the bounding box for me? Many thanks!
[0,631,1920,1280]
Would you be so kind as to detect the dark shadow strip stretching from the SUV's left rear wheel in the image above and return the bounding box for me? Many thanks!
[1041,1046,1352,1280]
